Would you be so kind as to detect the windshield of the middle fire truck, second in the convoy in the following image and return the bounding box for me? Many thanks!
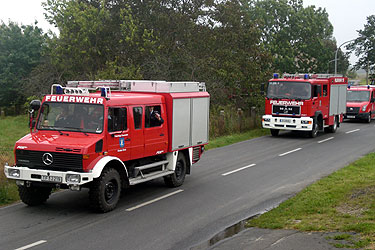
[267,81,311,100]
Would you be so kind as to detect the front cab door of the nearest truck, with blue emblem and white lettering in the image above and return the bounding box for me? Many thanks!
[107,107,130,161]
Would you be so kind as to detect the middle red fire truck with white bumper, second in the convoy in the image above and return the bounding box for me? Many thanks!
[262,74,348,137]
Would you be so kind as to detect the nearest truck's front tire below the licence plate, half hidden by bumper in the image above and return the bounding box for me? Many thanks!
[18,186,52,206]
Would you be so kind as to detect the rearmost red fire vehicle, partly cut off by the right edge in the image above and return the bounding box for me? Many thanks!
[344,85,375,123]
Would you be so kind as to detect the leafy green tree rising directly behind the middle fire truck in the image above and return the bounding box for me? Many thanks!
[248,0,346,73]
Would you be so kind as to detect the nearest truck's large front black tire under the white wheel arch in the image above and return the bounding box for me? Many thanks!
[89,168,121,213]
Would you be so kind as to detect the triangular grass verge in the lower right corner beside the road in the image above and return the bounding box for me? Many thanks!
[247,153,375,249]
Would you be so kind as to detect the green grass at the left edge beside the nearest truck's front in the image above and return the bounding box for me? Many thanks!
[0,115,29,206]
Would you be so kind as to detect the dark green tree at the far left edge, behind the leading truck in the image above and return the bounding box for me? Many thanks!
[0,22,46,112]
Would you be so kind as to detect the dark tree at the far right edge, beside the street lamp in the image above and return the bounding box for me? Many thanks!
[347,15,375,74]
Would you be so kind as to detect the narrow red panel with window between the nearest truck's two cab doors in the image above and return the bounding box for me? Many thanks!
[129,106,145,160]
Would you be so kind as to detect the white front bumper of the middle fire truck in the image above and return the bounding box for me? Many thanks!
[262,115,313,131]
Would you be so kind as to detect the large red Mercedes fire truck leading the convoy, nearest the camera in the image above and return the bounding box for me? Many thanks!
[4,80,209,212]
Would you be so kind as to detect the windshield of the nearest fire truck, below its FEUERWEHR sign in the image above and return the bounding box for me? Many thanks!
[37,102,104,133]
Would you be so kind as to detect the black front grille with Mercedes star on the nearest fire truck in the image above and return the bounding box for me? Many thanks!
[16,150,83,172]
